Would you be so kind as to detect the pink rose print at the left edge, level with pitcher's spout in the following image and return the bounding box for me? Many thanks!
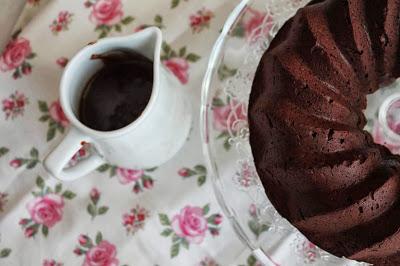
[0,36,36,79]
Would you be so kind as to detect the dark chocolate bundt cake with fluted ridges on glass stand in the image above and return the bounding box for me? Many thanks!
[249,0,400,265]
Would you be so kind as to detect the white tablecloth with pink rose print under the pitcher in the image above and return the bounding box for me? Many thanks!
[0,0,346,266]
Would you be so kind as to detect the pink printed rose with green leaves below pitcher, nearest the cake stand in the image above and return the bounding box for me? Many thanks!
[158,204,222,258]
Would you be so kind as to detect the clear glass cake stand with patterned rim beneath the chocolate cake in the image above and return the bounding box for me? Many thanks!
[201,0,400,266]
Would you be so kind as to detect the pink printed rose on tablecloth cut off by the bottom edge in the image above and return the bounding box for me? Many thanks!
[74,232,120,266]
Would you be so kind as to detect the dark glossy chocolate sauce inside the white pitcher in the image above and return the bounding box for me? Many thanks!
[79,50,153,131]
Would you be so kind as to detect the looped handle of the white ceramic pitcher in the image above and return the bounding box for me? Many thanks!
[44,127,104,181]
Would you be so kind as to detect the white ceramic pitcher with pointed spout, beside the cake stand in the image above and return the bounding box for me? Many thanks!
[44,27,191,181]
